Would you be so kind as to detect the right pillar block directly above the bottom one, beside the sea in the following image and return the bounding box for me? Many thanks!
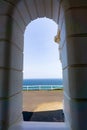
[64,67,87,99]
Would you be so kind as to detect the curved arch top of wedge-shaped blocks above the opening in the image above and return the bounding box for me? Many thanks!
[0,0,60,27]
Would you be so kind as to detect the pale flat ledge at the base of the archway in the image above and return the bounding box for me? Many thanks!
[9,122,68,130]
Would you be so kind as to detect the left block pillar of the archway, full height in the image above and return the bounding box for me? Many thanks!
[0,1,24,130]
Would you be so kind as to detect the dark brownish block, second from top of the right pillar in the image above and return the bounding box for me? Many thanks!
[65,8,87,36]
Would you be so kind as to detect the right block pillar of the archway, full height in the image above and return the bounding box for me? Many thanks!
[59,0,87,130]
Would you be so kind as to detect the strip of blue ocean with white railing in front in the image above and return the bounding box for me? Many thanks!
[23,79,63,91]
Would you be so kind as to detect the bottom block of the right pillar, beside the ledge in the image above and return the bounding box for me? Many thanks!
[64,95,87,130]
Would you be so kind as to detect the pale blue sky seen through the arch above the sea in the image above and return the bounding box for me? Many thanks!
[23,18,62,79]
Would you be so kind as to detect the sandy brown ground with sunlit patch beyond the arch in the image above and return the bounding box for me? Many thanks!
[23,90,63,112]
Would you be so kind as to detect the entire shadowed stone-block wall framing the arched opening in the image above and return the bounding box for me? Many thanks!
[0,0,87,130]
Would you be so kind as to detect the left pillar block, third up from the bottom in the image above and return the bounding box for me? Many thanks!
[0,41,23,70]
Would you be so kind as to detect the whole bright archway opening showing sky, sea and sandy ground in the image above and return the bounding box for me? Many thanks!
[23,18,63,122]
